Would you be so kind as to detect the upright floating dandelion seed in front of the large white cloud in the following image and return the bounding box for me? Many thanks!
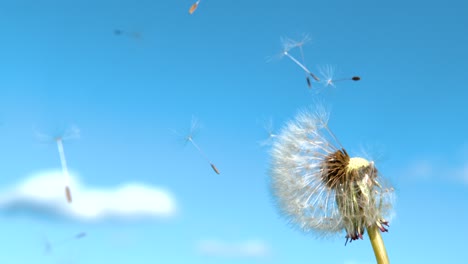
[36,127,80,203]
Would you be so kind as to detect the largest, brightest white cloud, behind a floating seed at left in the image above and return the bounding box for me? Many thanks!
[0,170,176,221]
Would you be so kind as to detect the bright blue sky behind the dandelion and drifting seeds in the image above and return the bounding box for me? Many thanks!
[0,0,468,264]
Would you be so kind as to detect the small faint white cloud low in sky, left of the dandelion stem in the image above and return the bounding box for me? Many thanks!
[197,240,270,258]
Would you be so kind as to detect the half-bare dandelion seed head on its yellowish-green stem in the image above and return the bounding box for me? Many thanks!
[271,108,393,263]
